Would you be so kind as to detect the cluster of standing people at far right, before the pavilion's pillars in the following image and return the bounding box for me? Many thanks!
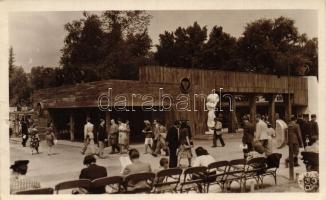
[242,114,319,167]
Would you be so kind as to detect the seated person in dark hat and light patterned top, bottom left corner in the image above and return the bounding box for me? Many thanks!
[10,160,41,194]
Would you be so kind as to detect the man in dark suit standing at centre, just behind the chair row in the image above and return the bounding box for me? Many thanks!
[166,121,180,168]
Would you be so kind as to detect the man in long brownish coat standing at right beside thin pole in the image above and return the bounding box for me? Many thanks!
[285,116,303,167]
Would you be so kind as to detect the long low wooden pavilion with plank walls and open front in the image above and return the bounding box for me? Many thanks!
[33,66,308,141]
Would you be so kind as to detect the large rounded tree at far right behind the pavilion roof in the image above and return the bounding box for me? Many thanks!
[238,17,318,75]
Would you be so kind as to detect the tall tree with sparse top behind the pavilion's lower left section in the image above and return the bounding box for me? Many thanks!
[59,11,151,84]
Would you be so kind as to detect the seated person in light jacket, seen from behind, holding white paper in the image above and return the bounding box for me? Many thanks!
[122,149,152,189]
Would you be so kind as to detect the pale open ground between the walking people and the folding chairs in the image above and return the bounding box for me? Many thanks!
[10,133,305,192]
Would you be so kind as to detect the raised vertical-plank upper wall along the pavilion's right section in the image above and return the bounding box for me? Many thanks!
[140,66,308,105]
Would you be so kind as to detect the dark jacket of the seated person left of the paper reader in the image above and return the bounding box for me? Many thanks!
[79,164,107,194]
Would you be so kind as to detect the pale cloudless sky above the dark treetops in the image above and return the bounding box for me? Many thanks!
[9,10,318,72]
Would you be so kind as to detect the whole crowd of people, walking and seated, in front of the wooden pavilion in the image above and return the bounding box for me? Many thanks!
[10,114,319,193]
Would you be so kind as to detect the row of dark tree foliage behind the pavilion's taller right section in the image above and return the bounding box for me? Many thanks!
[154,17,318,76]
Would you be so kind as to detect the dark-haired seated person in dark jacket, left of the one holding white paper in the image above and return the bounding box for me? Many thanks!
[79,155,107,194]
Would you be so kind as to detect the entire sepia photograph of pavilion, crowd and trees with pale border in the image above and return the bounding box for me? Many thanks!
[1,1,325,198]
